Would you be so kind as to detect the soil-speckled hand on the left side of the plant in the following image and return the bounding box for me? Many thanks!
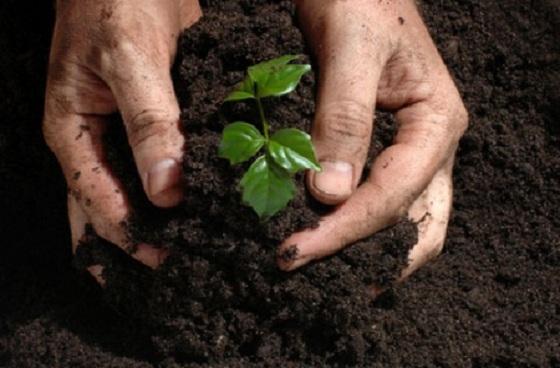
[43,0,201,279]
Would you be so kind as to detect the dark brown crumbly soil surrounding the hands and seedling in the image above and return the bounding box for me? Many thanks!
[0,0,560,367]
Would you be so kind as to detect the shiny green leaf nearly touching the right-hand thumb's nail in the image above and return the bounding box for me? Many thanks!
[268,129,321,174]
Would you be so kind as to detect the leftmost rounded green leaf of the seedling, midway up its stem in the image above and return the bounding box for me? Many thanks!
[218,121,265,165]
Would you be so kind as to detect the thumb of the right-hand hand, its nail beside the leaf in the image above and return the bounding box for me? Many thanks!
[307,3,387,204]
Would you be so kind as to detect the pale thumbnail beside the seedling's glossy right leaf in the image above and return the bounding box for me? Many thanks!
[313,161,353,196]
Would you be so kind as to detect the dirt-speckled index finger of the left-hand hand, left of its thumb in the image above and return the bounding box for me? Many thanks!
[44,102,165,268]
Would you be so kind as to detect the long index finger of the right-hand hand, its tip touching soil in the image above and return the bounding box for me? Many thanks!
[278,97,466,270]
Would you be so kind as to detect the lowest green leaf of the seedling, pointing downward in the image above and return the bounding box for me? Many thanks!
[240,155,296,219]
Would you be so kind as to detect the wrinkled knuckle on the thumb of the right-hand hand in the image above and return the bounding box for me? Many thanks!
[317,102,373,143]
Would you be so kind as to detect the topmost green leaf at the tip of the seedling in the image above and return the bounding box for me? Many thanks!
[248,55,311,98]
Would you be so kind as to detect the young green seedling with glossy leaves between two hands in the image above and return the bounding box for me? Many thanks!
[218,55,321,219]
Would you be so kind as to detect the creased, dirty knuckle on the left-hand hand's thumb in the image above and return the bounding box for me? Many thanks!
[127,109,177,147]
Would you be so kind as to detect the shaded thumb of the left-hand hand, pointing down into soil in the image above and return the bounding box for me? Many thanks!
[103,46,185,207]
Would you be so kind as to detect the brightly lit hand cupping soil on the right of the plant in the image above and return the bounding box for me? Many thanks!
[278,0,468,284]
